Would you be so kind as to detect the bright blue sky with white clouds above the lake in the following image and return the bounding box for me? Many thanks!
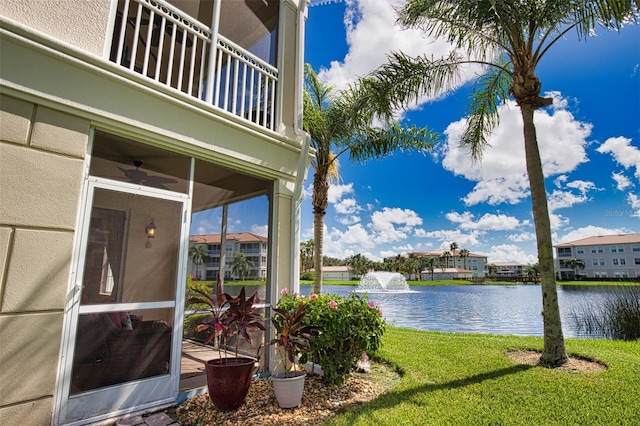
[193,0,640,263]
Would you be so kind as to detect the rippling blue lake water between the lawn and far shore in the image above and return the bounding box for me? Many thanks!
[300,285,608,337]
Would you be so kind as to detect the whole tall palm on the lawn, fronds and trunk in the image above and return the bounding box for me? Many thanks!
[370,0,640,367]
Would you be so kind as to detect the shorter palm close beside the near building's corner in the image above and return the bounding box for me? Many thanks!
[303,65,436,294]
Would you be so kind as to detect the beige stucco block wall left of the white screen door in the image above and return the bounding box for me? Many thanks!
[0,96,89,425]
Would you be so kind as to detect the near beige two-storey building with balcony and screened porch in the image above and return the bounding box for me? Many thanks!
[0,0,313,425]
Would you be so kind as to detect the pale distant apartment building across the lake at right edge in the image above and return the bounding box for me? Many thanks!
[555,233,640,279]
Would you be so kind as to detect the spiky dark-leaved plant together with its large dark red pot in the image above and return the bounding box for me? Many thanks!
[188,287,266,411]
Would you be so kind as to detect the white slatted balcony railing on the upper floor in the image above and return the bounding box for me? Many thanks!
[110,0,278,130]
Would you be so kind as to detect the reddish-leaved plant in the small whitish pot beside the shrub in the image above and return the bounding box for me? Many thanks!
[270,301,318,408]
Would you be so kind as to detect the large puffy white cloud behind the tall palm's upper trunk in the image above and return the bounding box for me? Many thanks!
[442,92,592,206]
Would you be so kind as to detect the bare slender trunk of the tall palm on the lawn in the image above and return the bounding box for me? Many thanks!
[520,103,568,367]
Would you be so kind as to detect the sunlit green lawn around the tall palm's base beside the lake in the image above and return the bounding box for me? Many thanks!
[329,328,640,426]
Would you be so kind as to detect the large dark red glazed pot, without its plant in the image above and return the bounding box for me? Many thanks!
[205,357,256,411]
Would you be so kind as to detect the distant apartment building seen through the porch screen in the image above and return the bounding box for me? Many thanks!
[189,232,269,280]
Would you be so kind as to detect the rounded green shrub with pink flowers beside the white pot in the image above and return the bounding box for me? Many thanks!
[278,293,385,385]
